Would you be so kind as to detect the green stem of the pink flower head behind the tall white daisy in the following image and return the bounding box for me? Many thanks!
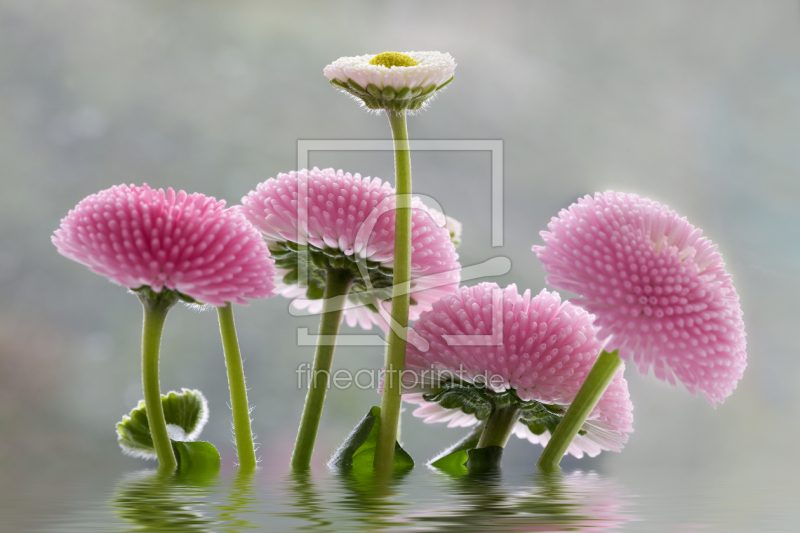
[292,269,353,470]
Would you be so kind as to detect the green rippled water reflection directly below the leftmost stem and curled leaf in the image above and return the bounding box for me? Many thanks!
[111,470,217,532]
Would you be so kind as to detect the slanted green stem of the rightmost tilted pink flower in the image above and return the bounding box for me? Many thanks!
[536,350,622,471]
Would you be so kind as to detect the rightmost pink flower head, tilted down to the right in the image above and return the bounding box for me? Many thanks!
[533,191,746,405]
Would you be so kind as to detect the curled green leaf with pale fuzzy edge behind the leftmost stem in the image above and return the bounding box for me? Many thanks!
[117,389,208,459]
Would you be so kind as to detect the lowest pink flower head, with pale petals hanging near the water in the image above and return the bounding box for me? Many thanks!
[403,283,633,458]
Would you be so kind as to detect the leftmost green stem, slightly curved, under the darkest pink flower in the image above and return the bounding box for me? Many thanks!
[140,291,178,472]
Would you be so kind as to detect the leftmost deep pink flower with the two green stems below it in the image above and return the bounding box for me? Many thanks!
[52,184,274,472]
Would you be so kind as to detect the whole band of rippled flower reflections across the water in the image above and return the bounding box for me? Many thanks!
[107,464,633,533]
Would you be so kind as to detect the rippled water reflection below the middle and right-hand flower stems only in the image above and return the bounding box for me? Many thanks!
[281,471,633,533]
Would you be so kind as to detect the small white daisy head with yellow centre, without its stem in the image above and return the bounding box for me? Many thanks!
[324,52,456,111]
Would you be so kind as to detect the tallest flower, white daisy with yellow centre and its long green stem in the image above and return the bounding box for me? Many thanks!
[324,52,456,472]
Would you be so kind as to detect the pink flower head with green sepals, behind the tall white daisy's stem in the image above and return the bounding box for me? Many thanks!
[242,168,461,331]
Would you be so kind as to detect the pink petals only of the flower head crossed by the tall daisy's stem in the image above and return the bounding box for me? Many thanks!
[242,168,461,330]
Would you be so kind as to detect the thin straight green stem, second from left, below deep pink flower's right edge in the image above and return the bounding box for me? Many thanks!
[217,303,257,470]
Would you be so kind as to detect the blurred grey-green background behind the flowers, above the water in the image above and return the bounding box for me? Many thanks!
[0,0,800,528]
